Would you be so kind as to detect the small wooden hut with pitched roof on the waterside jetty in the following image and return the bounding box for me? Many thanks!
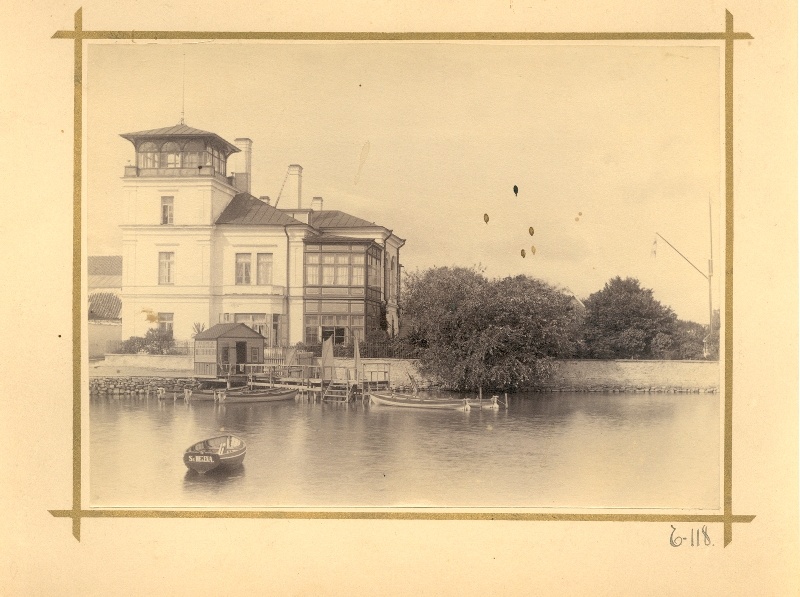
[194,323,266,377]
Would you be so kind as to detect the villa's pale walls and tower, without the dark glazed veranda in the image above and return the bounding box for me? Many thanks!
[121,125,404,345]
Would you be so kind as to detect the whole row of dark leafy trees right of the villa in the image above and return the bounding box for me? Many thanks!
[399,267,719,391]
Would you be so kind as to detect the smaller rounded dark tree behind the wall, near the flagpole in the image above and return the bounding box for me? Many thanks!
[583,276,677,359]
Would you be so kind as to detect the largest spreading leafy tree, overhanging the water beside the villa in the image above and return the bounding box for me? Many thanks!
[403,268,577,391]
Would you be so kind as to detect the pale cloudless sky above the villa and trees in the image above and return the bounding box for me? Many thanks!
[85,42,724,323]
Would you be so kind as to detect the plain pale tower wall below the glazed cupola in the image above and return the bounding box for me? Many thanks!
[121,172,237,339]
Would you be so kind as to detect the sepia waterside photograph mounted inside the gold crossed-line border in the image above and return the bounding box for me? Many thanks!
[89,41,725,512]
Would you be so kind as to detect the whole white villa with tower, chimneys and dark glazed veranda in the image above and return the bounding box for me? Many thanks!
[121,124,405,346]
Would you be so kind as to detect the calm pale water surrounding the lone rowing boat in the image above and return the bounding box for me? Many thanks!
[90,393,720,509]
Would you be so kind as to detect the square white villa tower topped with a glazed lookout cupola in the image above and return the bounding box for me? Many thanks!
[116,124,251,338]
